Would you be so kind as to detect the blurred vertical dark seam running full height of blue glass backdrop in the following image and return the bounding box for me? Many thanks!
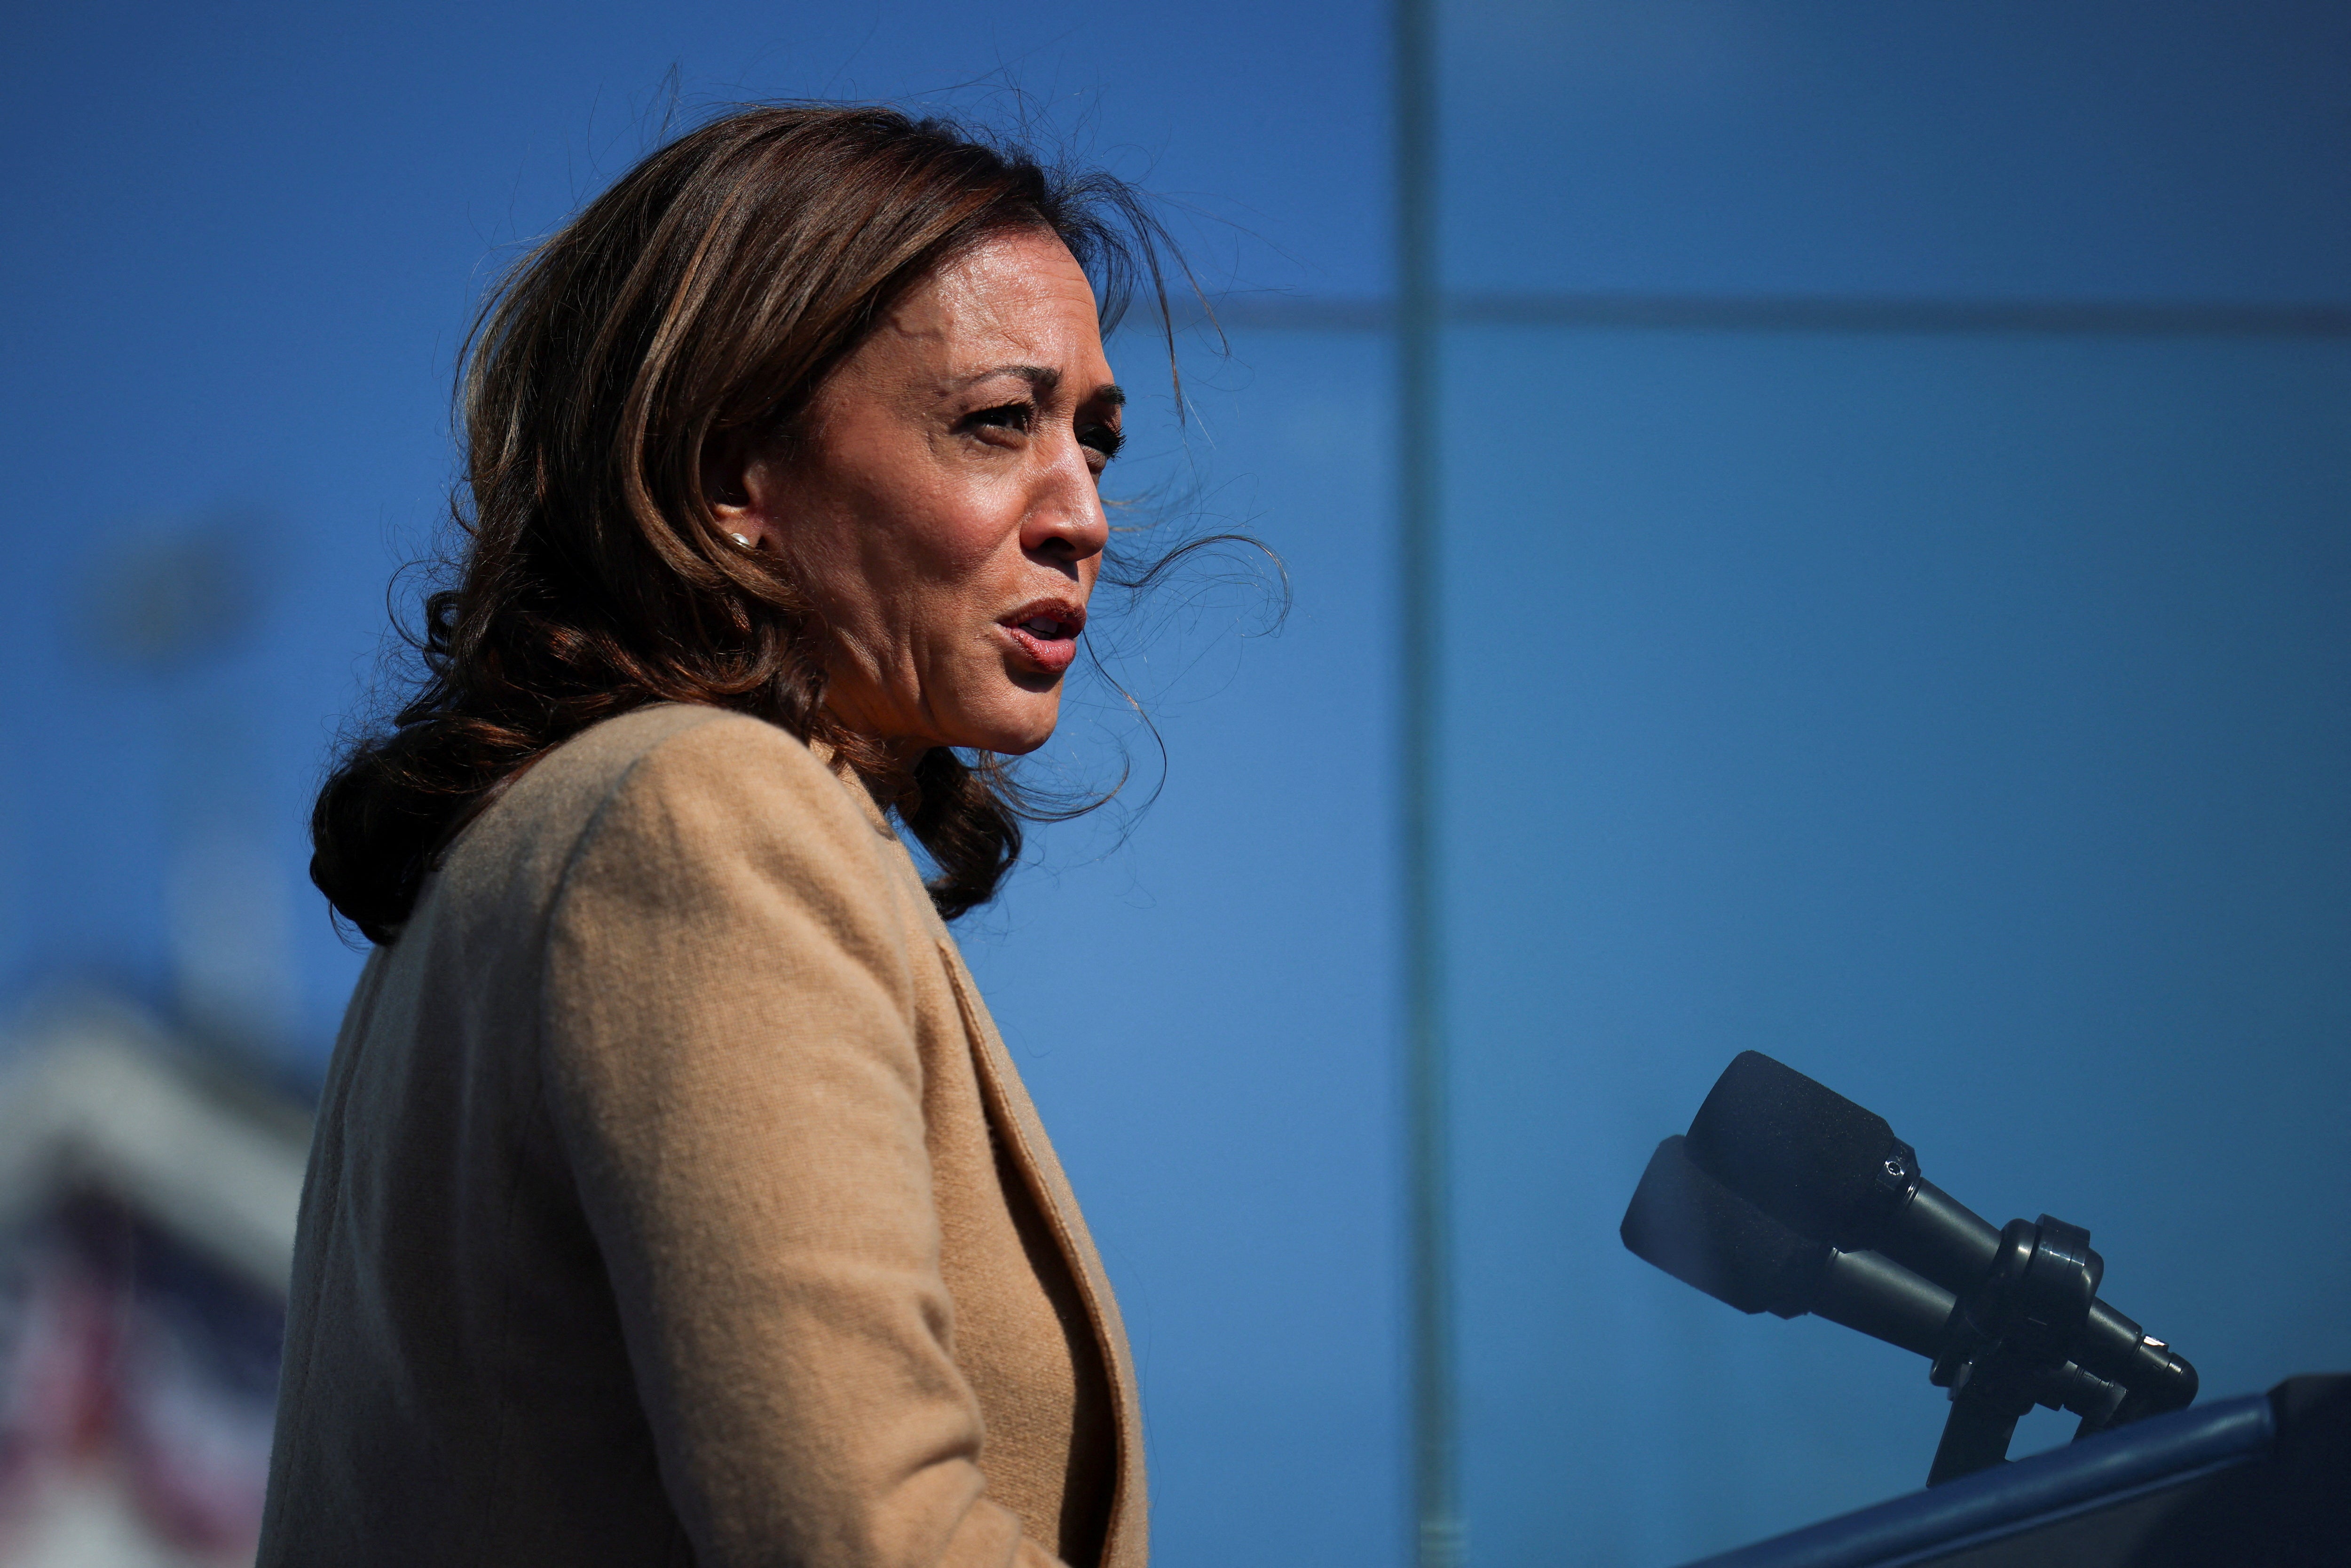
[1392,0,1462,1568]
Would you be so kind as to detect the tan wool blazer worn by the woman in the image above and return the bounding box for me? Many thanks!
[261,705,1145,1568]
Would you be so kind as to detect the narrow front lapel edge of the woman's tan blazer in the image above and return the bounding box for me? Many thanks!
[938,938,1150,1568]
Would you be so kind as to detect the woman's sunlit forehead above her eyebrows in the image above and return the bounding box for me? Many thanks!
[860,230,1107,378]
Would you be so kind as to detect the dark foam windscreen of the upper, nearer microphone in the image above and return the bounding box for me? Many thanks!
[1690,1051,1895,1251]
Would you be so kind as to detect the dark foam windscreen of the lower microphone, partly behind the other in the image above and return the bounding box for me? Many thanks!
[1617,1135,1829,1316]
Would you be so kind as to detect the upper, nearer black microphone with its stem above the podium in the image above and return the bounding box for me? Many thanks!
[1688,1051,2196,1420]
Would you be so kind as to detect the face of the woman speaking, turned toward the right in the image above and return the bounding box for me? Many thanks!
[708,230,1126,762]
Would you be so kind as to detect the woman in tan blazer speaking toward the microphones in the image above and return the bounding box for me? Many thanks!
[261,108,1159,1568]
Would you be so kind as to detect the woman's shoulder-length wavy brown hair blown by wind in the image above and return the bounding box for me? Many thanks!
[310,106,1173,943]
